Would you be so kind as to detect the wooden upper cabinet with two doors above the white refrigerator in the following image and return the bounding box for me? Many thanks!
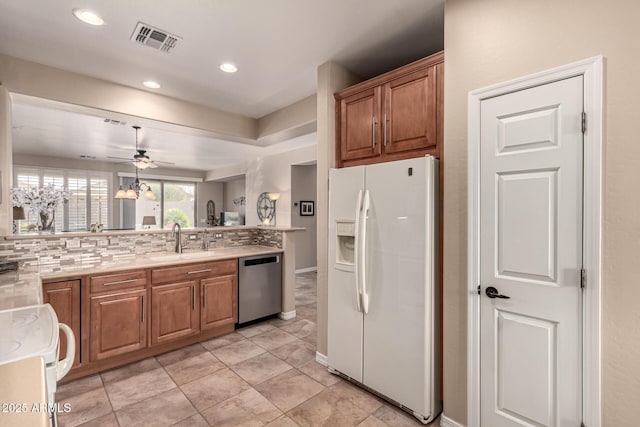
[335,52,444,167]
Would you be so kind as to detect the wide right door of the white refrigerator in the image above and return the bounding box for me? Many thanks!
[362,157,439,418]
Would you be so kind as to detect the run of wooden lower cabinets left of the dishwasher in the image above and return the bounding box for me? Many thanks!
[60,259,245,381]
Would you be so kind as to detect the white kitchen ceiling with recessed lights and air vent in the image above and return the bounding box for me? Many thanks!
[0,0,444,118]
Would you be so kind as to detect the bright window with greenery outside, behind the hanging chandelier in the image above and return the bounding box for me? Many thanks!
[129,179,196,228]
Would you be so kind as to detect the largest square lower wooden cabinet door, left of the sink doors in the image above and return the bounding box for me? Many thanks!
[89,289,148,361]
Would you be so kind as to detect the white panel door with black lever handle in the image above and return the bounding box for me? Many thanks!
[480,77,583,427]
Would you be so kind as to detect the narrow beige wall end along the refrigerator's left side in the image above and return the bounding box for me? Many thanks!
[316,62,362,355]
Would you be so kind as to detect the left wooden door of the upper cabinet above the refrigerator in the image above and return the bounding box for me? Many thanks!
[336,87,382,161]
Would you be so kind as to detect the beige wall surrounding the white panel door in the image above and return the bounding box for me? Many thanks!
[444,0,640,426]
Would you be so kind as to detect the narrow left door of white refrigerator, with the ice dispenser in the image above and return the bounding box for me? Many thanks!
[327,166,365,382]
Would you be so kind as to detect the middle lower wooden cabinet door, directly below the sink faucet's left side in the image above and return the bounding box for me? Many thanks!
[151,280,200,345]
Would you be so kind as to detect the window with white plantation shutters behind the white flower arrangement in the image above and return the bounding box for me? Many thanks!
[14,166,113,232]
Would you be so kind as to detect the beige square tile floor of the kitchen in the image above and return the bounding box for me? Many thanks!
[56,272,439,427]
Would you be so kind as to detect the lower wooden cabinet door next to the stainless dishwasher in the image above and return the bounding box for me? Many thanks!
[200,276,238,330]
